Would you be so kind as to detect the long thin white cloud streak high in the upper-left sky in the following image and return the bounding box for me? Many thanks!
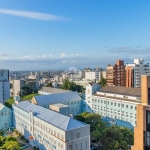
[0,9,66,21]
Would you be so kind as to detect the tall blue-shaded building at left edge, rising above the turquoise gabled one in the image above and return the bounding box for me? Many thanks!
[0,69,10,104]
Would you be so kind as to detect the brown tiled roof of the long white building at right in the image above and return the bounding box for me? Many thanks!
[100,86,141,97]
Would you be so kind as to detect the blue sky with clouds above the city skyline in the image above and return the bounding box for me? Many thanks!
[0,0,150,70]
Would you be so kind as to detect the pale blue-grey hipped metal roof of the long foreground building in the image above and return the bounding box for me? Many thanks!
[13,101,88,131]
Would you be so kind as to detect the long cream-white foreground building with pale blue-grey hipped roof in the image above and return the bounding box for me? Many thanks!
[13,101,90,150]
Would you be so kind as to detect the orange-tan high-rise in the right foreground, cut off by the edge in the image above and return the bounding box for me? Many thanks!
[132,75,150,150]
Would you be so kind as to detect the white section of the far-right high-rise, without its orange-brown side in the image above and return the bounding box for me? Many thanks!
[126,58,150,87]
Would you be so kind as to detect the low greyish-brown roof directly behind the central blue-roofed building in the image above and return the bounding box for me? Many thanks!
[39,87,70,94]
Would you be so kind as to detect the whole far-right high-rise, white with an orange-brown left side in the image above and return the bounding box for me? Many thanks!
[126,58,150,88]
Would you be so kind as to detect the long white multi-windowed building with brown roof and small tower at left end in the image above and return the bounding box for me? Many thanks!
[86,85,141,128]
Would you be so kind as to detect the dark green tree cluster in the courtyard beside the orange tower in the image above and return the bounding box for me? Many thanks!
[74,112,134,150]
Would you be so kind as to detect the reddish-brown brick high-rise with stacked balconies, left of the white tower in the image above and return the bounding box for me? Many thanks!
[106,60,126,86]
